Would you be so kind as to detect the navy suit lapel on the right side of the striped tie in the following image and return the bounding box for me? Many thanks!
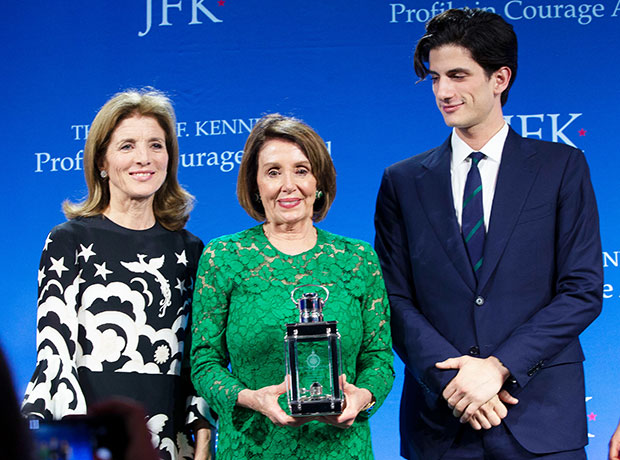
[478,129,540,291]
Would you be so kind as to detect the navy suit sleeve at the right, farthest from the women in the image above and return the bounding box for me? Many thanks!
[493,149,603,386]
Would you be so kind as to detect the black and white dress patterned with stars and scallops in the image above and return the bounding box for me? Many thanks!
[22,216,208,460]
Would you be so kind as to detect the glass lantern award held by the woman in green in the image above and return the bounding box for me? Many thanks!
[284,284,343,417]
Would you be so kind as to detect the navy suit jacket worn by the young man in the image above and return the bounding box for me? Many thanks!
[375,129,603,460]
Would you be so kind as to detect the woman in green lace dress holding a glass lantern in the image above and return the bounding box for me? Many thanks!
[191,114,394,460]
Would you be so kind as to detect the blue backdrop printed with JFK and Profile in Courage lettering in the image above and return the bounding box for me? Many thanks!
[0,0,620,459]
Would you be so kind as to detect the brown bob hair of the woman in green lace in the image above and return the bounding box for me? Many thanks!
[237,113,336,222]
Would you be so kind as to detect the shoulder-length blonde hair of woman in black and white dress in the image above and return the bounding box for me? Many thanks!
[63,88,194,230]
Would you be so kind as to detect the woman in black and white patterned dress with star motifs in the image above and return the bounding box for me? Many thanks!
[22,90,213,460]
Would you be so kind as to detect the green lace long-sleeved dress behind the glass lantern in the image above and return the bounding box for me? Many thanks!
[192,225,394,460]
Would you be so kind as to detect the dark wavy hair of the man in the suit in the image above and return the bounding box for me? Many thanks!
[413,8,518,106]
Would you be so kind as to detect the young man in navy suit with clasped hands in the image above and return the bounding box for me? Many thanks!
[375,9,603,460]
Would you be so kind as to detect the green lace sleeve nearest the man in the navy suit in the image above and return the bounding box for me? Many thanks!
[355,243,394,417]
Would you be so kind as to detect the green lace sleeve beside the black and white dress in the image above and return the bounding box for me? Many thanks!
[191,240,246,421]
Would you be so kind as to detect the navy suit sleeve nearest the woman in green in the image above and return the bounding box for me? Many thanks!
[375,170,461,395]
